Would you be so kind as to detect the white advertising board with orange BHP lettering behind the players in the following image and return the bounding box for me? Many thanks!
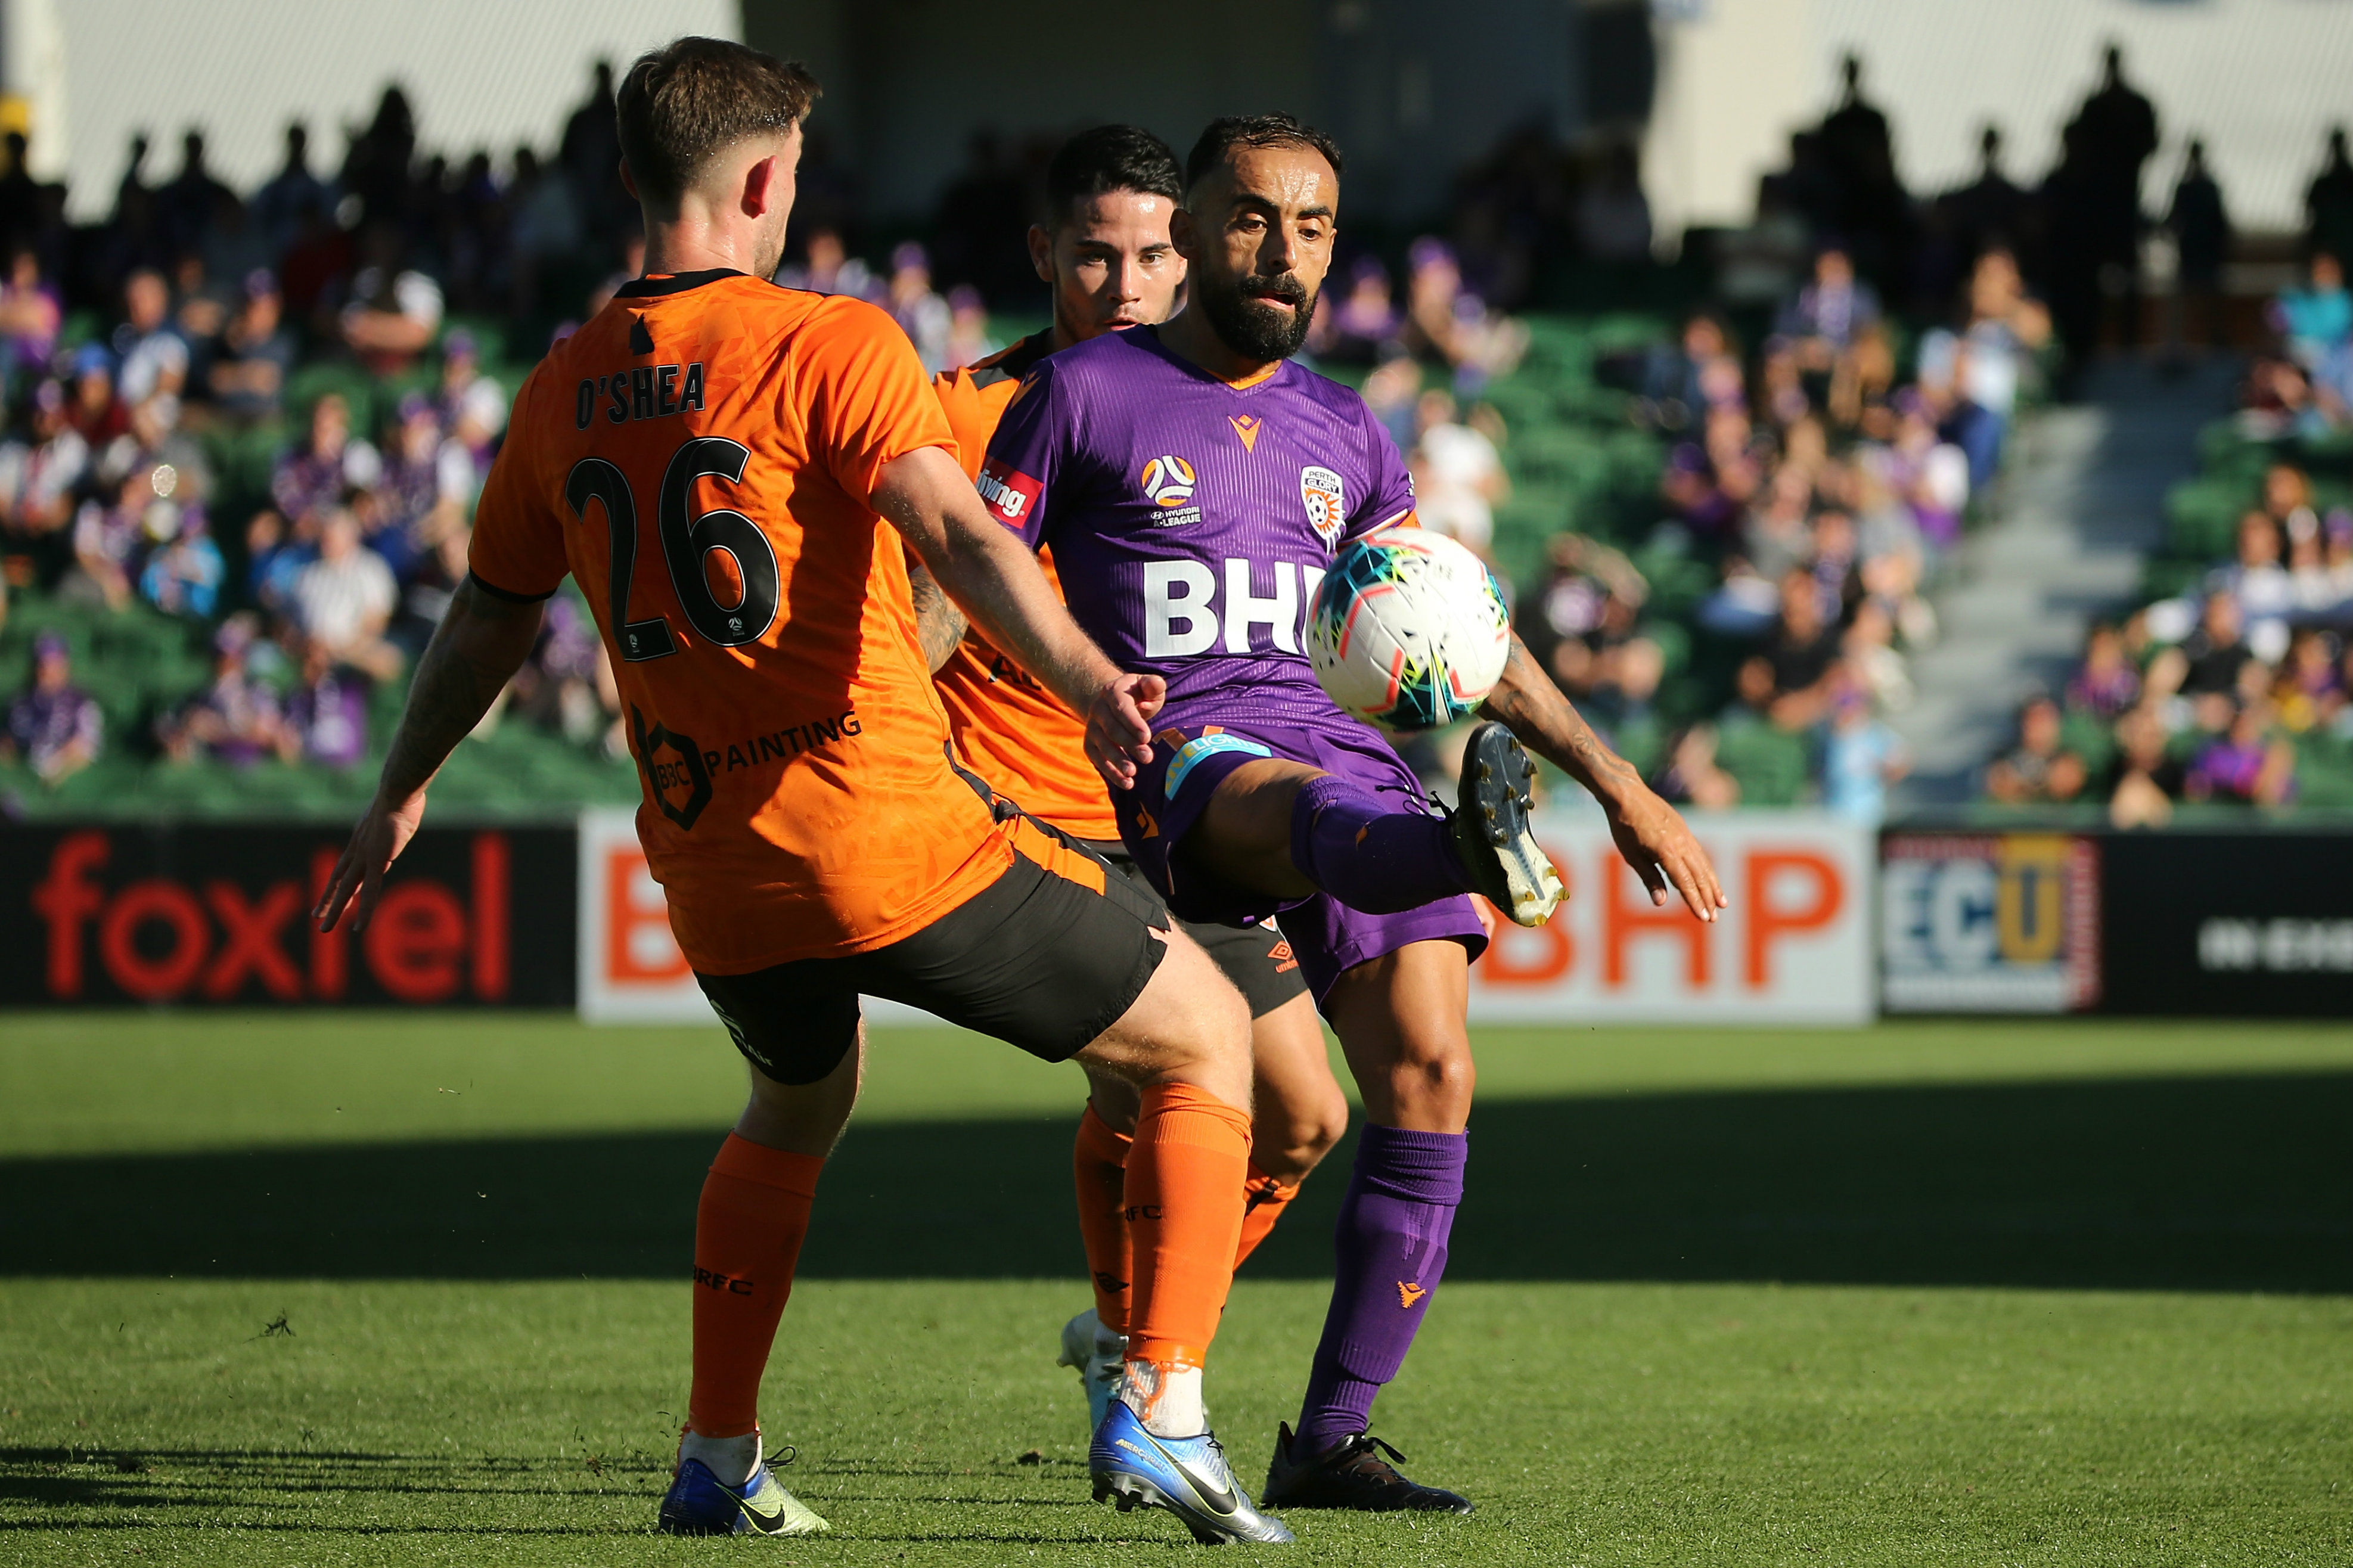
[579,810,1876,1024]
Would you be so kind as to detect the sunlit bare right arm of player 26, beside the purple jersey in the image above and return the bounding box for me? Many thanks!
[873,448,1167,788]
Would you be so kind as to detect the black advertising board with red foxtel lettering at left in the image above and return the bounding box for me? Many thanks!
[0,824,574,1008]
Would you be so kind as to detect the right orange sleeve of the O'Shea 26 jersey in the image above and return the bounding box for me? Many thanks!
[800,297,955,504]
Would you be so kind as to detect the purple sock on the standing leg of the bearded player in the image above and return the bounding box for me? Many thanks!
[1296,1125,1471,1455]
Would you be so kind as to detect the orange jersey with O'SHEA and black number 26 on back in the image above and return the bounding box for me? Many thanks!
[473,271,1012,974]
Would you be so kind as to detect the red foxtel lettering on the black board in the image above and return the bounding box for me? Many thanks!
[19,829,511,1003]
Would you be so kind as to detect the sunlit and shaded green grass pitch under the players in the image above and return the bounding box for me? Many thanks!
[0,1015,2353,1568]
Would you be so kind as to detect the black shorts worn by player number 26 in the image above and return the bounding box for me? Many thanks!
[694,822,1169,1083]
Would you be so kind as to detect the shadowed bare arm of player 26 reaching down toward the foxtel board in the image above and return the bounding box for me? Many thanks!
[311,577,541,930]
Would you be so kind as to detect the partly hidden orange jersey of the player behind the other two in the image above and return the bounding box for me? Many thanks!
[932,332,1120,840]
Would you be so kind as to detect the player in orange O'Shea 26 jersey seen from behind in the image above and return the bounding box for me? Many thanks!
[318,38,1290,1540]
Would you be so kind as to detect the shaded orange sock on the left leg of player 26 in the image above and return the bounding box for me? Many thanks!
[687,1132,826,1436]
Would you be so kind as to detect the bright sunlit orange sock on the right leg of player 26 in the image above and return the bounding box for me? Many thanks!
[1127,1083,1249,1368]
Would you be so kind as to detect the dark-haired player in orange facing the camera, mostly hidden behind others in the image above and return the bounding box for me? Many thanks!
[915,125,1348,1429]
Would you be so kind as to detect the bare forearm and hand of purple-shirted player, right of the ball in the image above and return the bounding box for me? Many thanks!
[1482,634,1730,921]
